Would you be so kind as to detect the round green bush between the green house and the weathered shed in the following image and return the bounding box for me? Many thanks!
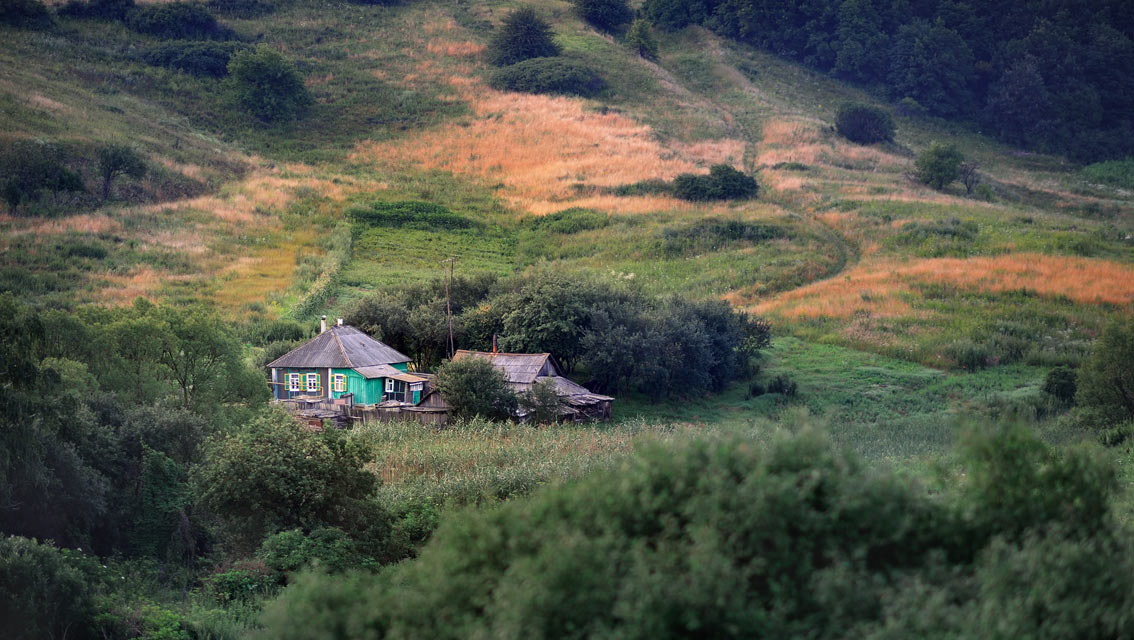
[437,357,516,420]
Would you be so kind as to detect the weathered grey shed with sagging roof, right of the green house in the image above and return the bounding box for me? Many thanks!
[452,350,615,420]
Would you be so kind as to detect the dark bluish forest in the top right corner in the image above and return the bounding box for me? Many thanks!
[643,0,1134,159]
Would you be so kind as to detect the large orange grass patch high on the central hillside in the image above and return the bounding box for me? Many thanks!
[353,77,744,213]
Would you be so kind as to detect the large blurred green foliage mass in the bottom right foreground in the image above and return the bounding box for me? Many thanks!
[259,427,1134,639]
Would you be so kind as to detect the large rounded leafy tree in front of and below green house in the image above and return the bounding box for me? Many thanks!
[193,411,388,551]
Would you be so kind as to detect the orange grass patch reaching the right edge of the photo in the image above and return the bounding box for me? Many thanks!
[752,253,1134,318]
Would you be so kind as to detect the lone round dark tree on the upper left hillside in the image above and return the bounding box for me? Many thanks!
[223,44,313,124]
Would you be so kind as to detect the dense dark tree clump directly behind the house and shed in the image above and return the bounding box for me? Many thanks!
[346,271,770,398]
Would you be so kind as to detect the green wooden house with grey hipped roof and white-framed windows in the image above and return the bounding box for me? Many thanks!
[268,319,426,404]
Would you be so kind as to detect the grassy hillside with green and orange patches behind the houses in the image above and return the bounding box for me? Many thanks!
[0,0,1134,501]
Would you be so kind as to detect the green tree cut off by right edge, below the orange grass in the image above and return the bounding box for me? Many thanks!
[1075,317,1134,423]
